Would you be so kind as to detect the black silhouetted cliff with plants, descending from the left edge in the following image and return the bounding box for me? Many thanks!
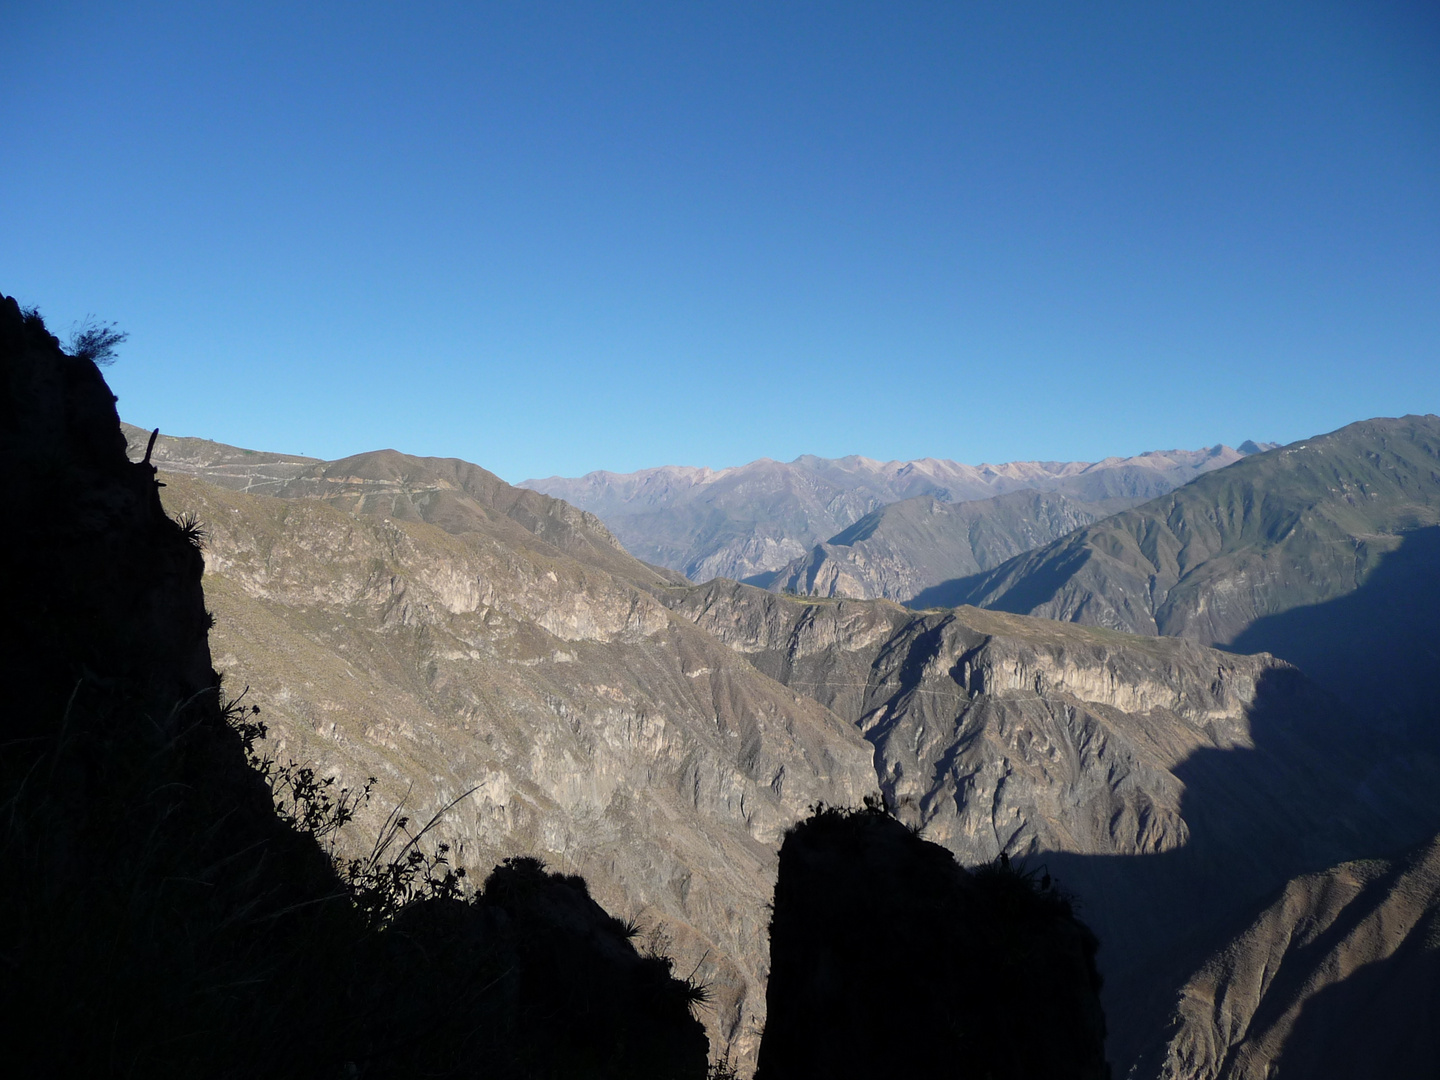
[0,298,707,1080]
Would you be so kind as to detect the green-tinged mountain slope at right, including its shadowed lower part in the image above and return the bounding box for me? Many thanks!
[933,416,1440,728]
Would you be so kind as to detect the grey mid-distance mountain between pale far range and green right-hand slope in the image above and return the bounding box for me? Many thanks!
[756,491,1138,602]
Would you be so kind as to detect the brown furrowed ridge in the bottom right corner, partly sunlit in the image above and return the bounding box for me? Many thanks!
[1138,838,1440,1080]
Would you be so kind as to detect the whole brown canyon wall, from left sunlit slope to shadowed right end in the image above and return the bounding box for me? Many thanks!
[129,423,1433,1073]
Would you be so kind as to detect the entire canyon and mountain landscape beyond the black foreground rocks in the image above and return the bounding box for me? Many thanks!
[127,416,1440,1077]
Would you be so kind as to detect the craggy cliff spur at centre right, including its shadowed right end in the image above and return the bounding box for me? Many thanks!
[656,582,1434,1073]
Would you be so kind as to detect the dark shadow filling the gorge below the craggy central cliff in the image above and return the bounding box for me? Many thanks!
[1027,668,1440,1076]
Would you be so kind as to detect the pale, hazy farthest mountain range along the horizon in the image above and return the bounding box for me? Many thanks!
[520,444,1272,582]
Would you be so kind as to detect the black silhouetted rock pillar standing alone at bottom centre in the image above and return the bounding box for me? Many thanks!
[756,806,1110,1080]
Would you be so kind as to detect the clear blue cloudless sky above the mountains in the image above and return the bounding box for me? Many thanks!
[0,0,1440,481]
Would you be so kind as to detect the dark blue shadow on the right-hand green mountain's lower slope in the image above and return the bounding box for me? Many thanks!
[1221,526,1440,749]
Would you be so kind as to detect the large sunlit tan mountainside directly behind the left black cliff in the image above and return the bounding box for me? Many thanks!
[149,472,874,1060]
